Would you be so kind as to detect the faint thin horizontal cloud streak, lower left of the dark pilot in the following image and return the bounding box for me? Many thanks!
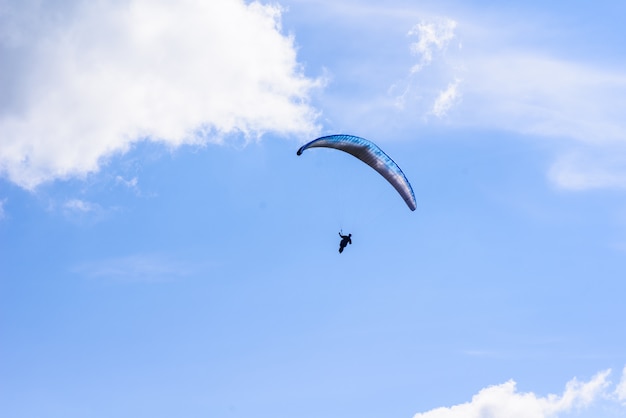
[72,254,200,282]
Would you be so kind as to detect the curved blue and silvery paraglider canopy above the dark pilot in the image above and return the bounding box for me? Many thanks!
[297,135,417,211]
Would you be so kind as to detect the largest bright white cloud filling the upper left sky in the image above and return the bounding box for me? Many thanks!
[0,0,319,189]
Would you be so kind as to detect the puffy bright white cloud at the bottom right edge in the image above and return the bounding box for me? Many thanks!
[414,370,610,418]
